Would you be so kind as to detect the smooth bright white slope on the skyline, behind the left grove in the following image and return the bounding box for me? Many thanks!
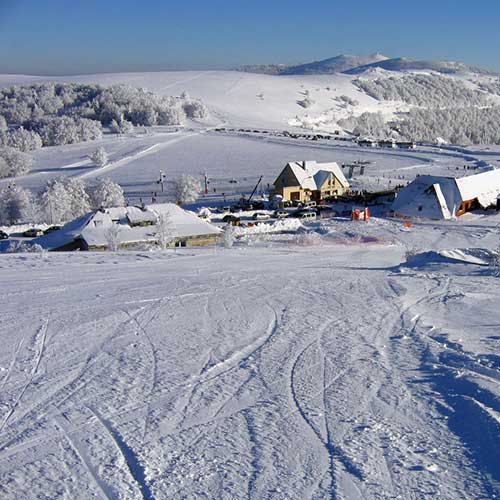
[0,71,408,129]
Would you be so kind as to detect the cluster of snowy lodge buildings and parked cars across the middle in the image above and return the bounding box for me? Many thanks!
[2,139,500,251]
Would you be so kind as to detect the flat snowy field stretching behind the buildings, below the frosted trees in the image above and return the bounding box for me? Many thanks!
[0,126,500,207]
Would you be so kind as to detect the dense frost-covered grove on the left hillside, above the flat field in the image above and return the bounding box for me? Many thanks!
[0,83,208,151]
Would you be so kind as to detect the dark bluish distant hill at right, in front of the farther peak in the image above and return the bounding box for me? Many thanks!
[344,57,494,75]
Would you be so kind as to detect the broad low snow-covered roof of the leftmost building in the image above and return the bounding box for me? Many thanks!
[33,203,222,250]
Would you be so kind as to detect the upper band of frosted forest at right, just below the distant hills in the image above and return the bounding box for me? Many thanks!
[353,75,489,108]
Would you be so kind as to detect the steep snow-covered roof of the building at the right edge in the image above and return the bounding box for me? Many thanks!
[392,170,500,219]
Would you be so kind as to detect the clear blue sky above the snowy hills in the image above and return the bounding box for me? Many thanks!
[0,0,500,75]
